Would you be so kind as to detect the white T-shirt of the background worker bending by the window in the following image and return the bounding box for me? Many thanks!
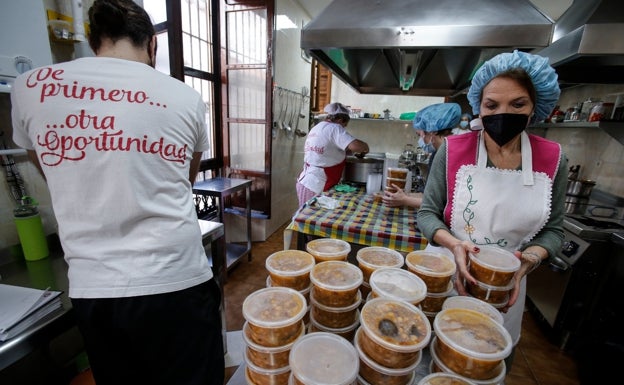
[298,121,355,193]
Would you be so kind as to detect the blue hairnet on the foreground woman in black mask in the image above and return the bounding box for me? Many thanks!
[468,50,561,121]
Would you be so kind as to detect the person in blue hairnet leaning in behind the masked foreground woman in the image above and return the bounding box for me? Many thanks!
[382,103,461,208]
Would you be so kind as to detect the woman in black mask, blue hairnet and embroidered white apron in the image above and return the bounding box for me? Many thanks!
[417,51,567,369]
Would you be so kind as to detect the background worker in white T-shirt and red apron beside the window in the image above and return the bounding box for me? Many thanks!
[296,103,369,207]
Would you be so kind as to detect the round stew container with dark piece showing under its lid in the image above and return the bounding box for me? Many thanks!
[357,298,431,369]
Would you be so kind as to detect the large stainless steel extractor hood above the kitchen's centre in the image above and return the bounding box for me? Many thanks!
[301,0,553,96]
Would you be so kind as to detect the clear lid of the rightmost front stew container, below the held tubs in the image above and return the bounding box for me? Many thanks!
[433,308,512,361]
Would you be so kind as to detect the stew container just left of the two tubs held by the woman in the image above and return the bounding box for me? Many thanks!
[405,250,457,293]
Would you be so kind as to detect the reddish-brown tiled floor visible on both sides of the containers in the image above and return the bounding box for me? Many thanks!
[224,222,581,385]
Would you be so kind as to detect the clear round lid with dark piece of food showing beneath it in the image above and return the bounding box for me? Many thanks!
[360,297,431,352]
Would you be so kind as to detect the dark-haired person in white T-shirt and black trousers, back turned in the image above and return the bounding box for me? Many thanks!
[11,0,225,385]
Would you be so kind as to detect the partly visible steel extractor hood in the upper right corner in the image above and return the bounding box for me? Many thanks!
[533,0,624,85]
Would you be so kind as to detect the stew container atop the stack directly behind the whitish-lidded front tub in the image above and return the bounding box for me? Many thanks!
[310,261,364,307]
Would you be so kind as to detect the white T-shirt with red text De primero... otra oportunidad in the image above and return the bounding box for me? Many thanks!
[11,57,212,298]
